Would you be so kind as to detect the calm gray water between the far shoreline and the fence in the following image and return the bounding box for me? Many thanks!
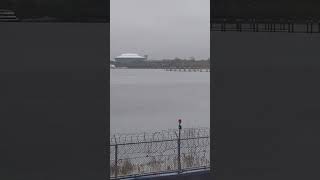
[110,69,210,133]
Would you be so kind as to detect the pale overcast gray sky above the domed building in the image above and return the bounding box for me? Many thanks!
[110,0,210,59]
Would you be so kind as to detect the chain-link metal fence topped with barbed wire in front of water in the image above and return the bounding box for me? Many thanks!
[109,128,210,179]
